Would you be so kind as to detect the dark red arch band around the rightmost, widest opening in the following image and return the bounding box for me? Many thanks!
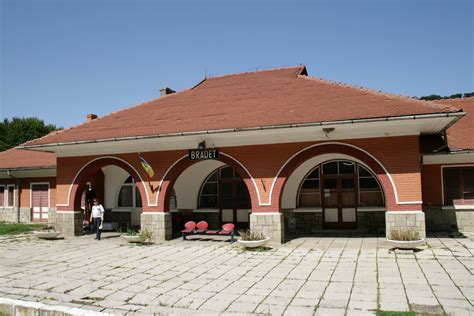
[271,143,400,210]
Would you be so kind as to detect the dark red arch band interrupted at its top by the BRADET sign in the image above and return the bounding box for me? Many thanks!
[156,152,260,212]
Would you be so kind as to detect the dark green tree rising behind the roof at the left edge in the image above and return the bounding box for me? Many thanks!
[0,117,61,151]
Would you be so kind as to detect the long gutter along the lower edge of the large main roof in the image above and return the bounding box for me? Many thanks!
[15,110,466,149]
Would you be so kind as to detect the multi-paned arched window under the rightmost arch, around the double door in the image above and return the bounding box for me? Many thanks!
[297,160,385,207]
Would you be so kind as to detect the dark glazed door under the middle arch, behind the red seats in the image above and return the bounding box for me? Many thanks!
[219,179,250,228]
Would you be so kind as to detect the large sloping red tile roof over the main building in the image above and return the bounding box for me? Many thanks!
[21,66,457,145]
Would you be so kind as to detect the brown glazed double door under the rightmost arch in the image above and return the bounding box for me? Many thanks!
[321,161,357,229]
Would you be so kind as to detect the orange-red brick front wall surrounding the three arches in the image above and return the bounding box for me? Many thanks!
[57,136,422,212]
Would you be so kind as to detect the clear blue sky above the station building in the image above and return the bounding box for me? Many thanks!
[0,0,474,127]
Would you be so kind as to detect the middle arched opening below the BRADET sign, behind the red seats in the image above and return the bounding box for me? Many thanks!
[168,160,252,236]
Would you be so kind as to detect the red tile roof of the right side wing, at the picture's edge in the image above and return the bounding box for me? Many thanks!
[436,97,474,149]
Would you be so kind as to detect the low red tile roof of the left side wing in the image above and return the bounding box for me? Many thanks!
[0,149,56,169]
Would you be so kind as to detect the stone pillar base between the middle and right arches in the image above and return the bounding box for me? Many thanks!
[250,212,285,245]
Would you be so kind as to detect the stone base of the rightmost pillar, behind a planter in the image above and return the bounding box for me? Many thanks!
[385,211,426,238]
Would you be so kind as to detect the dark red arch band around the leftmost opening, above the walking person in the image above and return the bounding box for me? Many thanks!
[68,156,149,210]
